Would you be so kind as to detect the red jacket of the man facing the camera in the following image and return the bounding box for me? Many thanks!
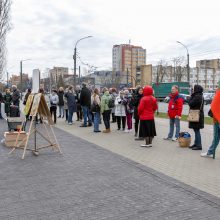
[168,93,183,119]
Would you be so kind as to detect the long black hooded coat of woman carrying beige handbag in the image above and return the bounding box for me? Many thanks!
[189,85,204,129]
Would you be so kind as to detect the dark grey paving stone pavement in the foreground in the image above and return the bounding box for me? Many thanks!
[0,121,220,220]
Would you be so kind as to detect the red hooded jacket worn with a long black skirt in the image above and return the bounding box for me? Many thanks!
[138,86,157,120]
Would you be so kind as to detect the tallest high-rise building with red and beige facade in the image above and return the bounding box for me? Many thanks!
[112,44,146,86]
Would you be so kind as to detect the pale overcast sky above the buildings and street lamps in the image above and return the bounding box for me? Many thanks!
[7,0,220,75]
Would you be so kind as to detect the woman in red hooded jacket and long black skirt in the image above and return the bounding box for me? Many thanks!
[138,86,157,147]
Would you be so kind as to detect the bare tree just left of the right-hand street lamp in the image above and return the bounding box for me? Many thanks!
[172,57,186,82]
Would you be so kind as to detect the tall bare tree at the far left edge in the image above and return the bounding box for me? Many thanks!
[0,0,11,79]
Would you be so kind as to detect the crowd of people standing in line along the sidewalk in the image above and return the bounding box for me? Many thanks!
[0,83,220,157]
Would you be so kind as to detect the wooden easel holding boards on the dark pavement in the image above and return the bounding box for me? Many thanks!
[9,93,62,159]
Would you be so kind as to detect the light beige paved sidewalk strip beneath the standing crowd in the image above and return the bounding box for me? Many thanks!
[57,119,220,197]
